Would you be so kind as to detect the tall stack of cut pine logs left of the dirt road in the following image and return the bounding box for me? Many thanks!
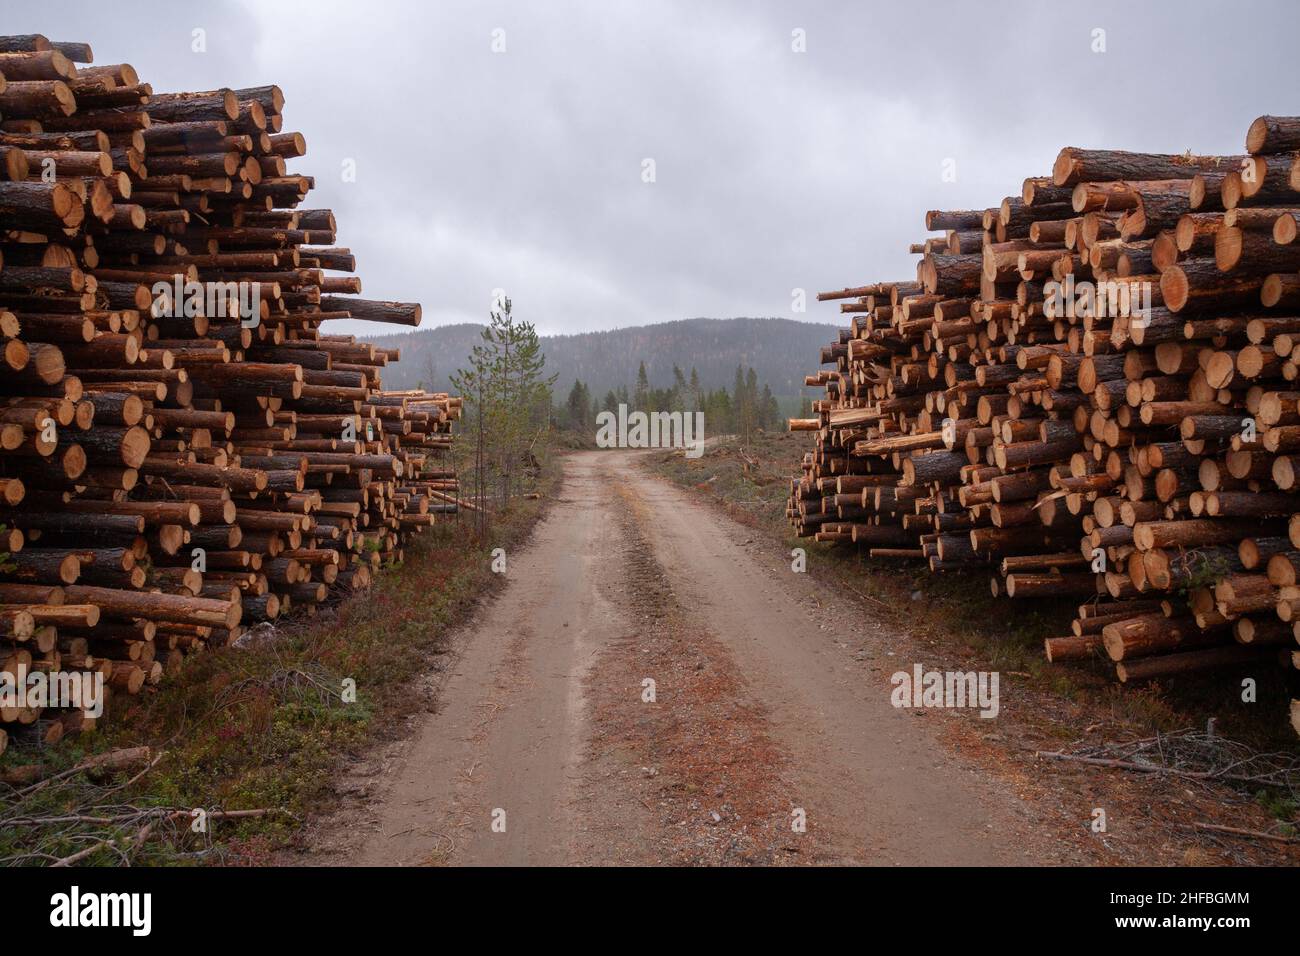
[0,35,460,749]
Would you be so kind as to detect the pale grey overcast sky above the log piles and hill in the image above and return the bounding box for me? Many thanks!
[12,0,1300,333]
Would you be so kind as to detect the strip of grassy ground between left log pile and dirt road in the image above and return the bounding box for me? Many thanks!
[0,471,554,865]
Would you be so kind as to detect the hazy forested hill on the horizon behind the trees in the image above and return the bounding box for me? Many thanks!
[368,319,837,402]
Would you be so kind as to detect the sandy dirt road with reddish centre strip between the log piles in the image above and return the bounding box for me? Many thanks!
[306,453,1069,865]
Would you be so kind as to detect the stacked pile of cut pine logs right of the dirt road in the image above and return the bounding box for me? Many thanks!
[788,116,1300,730]
